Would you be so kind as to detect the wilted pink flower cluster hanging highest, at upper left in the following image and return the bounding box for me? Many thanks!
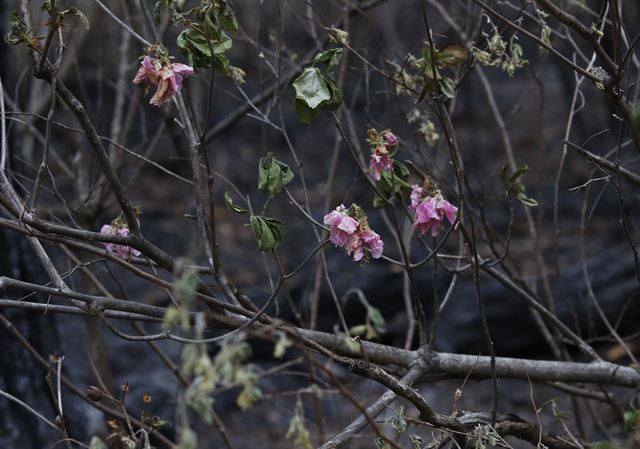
[133,56,193,106]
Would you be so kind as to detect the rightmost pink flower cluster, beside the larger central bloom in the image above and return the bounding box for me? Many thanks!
[410,184,458,237]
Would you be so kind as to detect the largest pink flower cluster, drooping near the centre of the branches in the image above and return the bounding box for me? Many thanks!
[324,204,384,262]
